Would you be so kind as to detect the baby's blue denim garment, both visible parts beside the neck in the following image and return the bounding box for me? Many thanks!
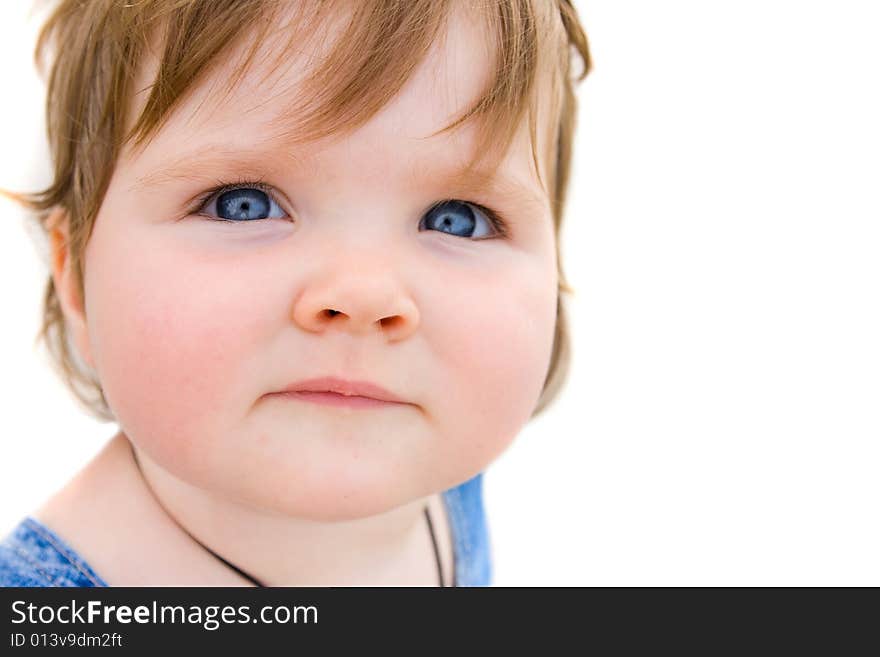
[0,473,492,586]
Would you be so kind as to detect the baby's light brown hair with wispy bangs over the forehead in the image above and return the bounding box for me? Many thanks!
[0,0,591,421]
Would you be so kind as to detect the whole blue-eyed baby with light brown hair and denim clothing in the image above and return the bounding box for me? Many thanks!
[0,0,590,586]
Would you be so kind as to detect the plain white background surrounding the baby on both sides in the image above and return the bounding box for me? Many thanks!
[0,0,880,586]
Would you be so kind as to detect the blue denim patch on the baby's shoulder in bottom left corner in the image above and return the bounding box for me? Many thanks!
[0,516,106,587]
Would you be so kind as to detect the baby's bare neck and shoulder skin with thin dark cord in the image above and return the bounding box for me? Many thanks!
[34,433,452,586]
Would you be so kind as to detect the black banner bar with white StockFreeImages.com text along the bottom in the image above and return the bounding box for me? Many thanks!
[0,587,878,655]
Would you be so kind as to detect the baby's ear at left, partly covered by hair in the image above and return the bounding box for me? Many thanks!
[46,206,94,369]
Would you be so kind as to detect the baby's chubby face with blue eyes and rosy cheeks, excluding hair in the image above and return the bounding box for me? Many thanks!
[77,5,557,519]
